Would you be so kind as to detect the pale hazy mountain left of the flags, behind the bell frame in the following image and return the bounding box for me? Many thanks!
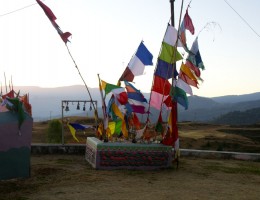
[14,85,102,121]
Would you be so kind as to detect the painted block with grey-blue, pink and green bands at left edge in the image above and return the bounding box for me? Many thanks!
[0,111,33,180]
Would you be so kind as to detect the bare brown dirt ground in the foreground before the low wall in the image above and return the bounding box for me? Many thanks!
[0,155,260,200]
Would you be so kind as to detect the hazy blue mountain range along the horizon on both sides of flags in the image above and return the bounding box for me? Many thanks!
[11,85,260,122]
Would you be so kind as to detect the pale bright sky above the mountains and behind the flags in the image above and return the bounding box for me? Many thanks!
[0,0,260,97]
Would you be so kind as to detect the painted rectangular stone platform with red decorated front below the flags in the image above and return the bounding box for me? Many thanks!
[85,137,172,170]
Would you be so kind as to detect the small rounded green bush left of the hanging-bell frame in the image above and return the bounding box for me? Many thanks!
[47,119,62,143]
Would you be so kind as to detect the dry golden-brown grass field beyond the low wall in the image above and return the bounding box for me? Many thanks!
[32,117,260,153]
